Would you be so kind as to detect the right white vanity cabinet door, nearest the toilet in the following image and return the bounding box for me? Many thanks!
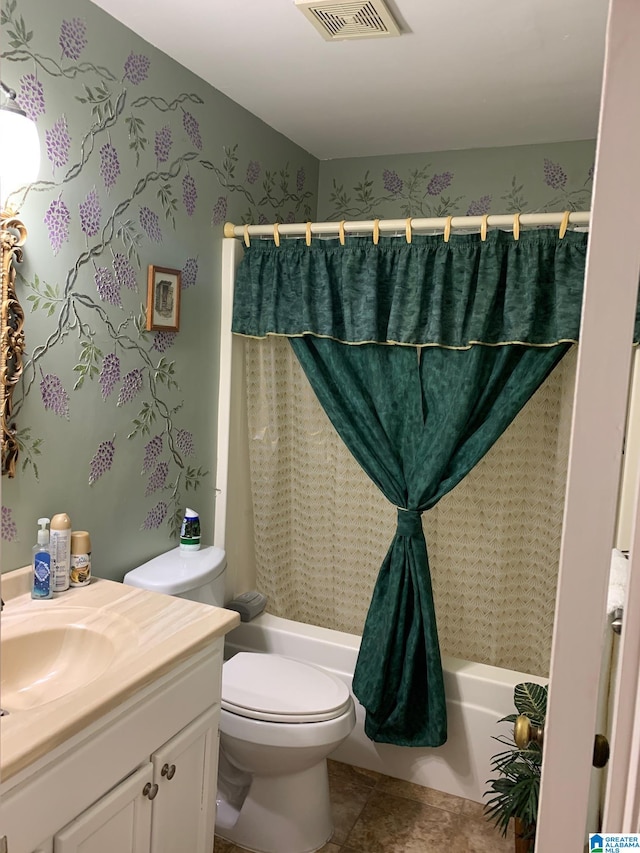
[151,707,219,853]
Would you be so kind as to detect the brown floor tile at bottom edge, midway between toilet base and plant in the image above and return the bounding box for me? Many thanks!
[345,791,460,853]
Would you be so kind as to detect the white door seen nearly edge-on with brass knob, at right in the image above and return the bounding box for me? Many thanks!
[536,0,640,853]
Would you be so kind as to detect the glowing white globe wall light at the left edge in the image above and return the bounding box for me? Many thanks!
[0,80,40,213]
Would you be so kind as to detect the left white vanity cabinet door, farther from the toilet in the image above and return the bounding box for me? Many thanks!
[53,764,152,853]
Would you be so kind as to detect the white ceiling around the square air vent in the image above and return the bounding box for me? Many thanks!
[87,0,607,159]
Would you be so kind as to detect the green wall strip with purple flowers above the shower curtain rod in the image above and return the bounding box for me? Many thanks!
[318,140,595,220]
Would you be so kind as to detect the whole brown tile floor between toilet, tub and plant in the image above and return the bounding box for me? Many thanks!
[215,761,514,853]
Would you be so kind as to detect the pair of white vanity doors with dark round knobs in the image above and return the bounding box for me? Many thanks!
[53,708,218,853]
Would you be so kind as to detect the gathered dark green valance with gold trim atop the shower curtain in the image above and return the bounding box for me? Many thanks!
[233,229,596,349]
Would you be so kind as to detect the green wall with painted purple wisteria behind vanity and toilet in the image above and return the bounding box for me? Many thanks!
[0,0,318,578]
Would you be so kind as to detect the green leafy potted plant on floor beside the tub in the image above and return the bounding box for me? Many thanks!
[484,682,548,853]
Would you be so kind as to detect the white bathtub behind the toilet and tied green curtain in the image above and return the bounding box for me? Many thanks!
[225,613,547,802]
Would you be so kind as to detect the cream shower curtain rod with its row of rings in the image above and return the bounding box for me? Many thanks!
[224,210,591,243]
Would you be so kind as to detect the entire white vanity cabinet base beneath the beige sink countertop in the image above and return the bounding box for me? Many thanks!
[1,639,222,853]
